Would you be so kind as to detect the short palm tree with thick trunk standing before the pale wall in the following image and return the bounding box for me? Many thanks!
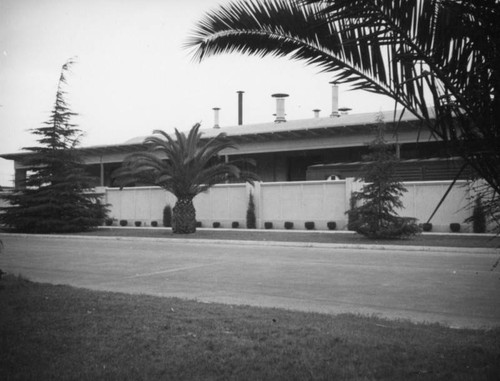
[113,123,257,234]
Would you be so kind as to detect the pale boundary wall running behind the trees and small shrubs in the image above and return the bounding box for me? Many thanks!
[103,179,478,231]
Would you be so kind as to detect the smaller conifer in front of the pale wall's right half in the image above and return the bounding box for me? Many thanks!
[347,116,419,238]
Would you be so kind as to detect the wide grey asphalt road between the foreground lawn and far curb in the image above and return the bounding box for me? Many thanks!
[0,234,500,328]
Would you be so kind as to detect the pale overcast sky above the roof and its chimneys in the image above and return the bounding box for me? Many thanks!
[0,0,393,185]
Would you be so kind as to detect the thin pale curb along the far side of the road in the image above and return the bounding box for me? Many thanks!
[0,233,500,254]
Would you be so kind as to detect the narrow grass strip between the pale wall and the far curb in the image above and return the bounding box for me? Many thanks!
[73,227,500,248]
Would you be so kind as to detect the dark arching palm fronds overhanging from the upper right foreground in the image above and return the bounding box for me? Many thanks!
[187,0,500,226]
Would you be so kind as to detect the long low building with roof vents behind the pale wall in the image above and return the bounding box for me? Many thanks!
[0,103,470,187]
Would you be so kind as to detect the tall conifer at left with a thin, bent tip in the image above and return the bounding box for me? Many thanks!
[0,60,107,233]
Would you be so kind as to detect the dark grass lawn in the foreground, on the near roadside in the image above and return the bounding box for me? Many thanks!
[0,276,500,380]
